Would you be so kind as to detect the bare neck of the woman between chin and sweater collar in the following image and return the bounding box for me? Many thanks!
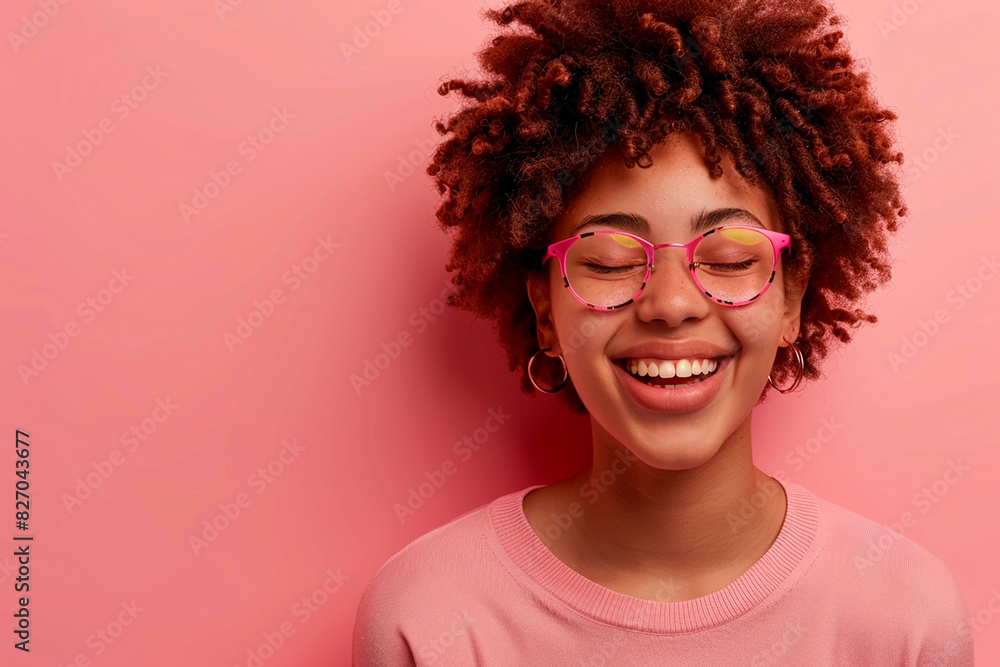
[524,424,786,602]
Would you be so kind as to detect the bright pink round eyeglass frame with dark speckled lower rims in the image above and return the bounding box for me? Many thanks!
[541,225,792,311]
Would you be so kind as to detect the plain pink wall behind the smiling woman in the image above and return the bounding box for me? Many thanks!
[0,0,1000,666]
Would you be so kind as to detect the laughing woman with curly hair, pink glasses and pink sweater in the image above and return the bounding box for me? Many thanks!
[354,0,973,666]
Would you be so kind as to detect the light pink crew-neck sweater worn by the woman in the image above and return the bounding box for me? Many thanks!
[354,480,973,667]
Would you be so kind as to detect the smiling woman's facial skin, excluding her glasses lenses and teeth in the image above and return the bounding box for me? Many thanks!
[528,135,804,470]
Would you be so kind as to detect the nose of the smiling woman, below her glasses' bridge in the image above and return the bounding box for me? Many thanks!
[632,243,711,326]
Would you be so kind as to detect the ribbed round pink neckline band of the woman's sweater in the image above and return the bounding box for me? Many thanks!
[489,478,819,634]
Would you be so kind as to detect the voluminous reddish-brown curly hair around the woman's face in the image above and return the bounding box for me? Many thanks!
[427,0,907,414]
